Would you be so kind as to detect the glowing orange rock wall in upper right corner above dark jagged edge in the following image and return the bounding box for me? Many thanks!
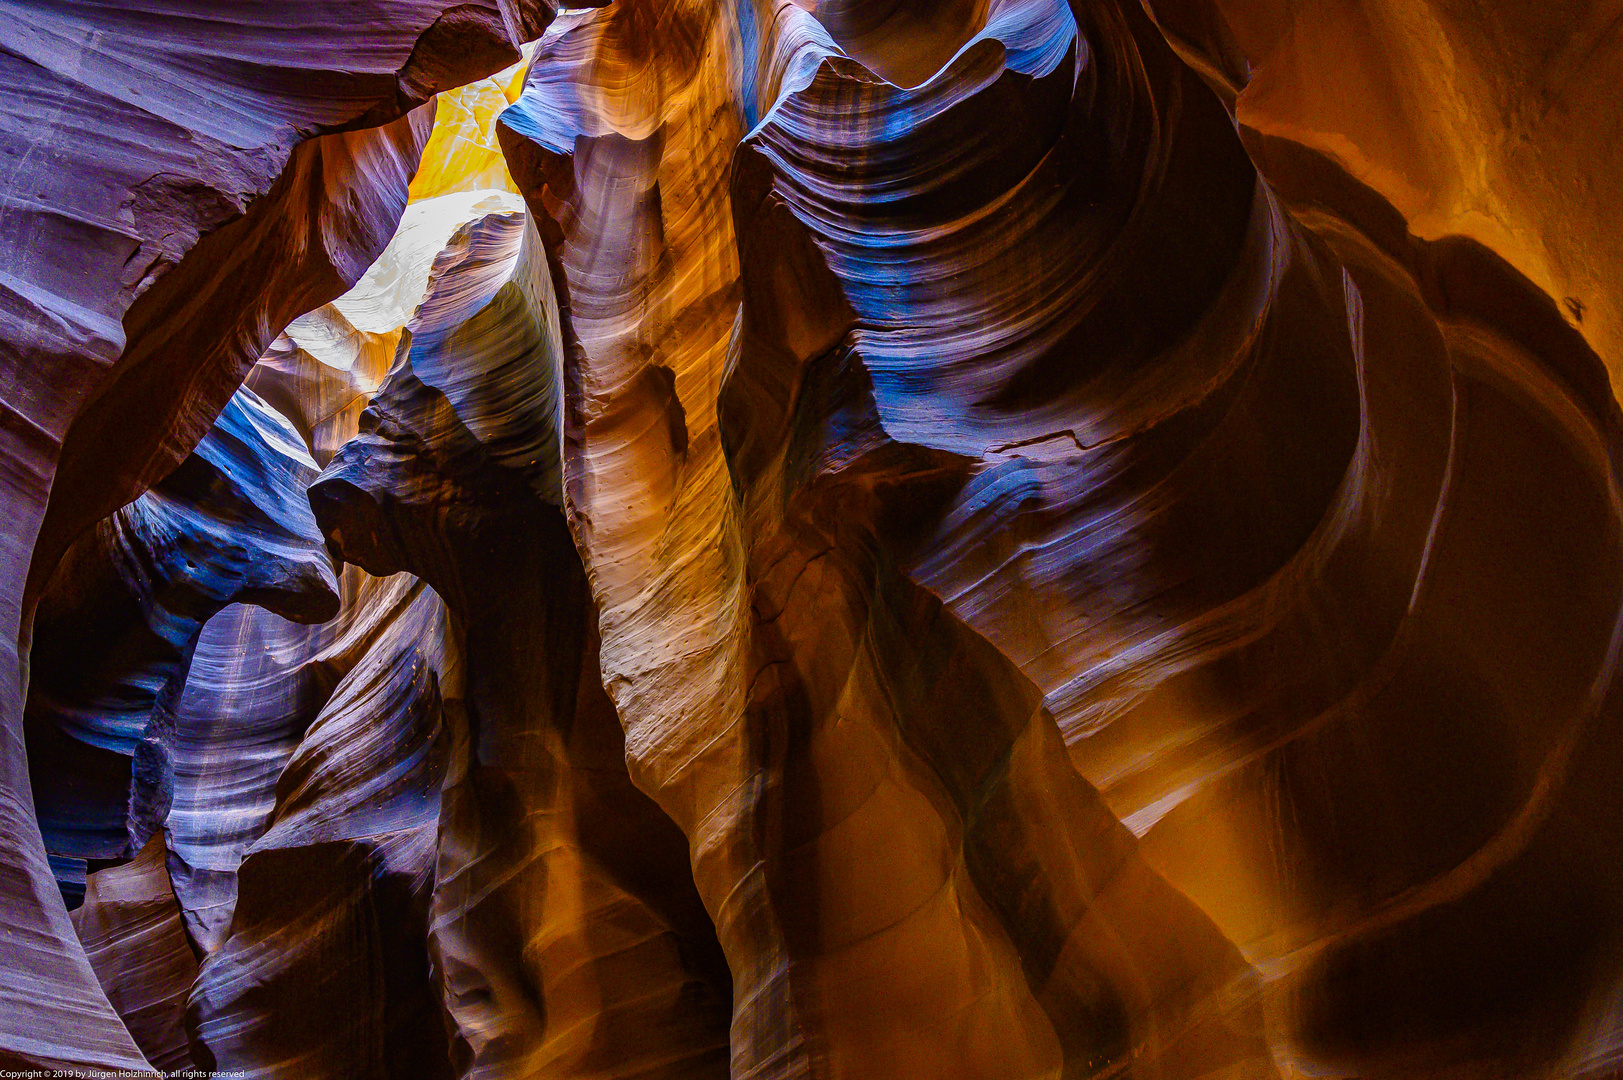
[1146,0,1623,391]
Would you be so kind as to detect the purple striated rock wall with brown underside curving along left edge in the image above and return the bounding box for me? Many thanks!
[0,0,552,1069]
